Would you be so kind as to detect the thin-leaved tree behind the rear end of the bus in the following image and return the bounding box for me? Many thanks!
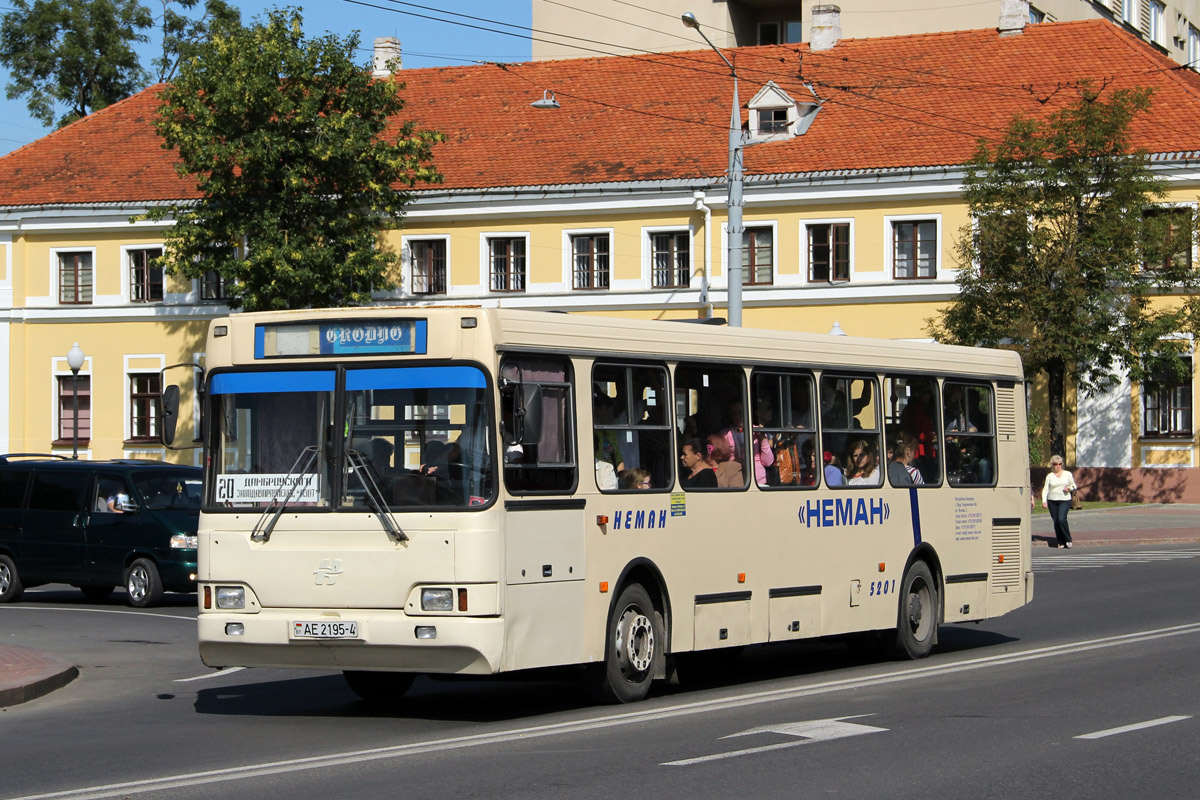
[929,85,1200,462]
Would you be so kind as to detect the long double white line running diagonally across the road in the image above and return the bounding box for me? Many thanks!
[6,622,1200,800]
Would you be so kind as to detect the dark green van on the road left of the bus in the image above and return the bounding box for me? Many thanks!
[0,453,200,608]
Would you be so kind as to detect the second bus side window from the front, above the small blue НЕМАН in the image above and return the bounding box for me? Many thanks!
[592,362,674,492]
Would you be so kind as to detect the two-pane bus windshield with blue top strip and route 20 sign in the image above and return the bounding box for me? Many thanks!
[210,366,496,511]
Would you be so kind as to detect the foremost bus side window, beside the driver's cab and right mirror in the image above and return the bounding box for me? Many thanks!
[499,355,577,494]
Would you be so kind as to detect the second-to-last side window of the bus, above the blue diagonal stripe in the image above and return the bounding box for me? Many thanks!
[883,375,942,486]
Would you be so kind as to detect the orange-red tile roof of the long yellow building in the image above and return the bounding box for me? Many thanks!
[0,20,1200,206]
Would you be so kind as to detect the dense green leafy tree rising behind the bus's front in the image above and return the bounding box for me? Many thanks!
[152,10,440,311]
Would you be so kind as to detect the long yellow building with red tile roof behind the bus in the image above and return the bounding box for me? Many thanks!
[0,20,1200,492]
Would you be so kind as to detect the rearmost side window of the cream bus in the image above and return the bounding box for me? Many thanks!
[943,380,996,486]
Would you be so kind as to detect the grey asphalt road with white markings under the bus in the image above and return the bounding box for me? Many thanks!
[0,545,1200,800]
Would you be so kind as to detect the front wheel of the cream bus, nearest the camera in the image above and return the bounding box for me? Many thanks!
[589,583,666,703]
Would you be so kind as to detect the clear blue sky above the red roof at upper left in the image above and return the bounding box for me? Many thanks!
[0,0,532,155]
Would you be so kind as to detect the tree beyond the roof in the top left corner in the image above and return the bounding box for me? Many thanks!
[0,0,154,127]
